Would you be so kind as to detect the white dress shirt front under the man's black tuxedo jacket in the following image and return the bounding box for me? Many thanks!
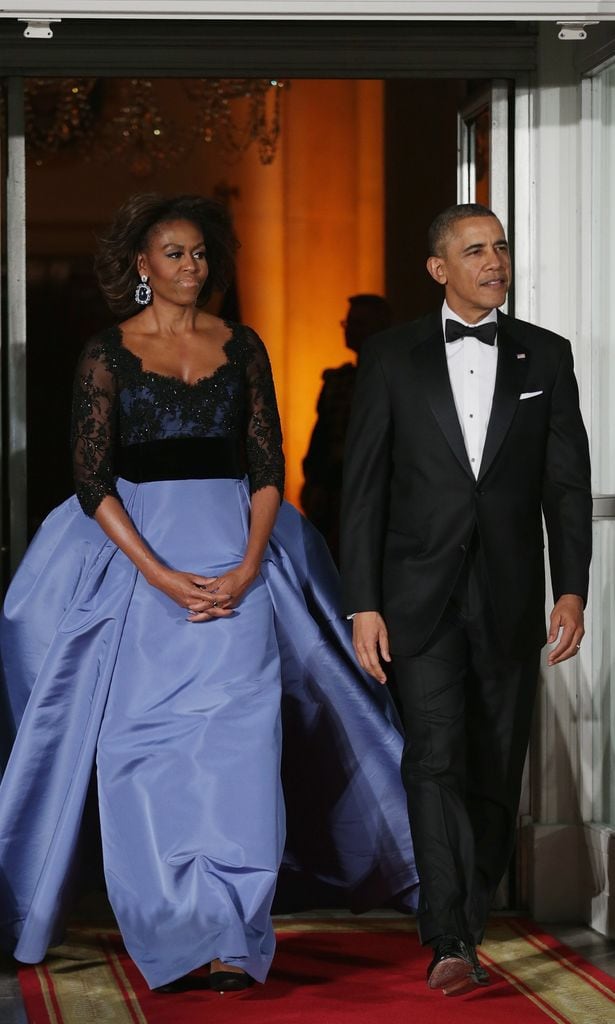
[442,300,497,476]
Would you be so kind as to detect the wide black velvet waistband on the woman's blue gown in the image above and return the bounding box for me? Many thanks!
[115,437,246,483]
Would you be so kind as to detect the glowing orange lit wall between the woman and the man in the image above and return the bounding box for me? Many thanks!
[232,81,385,504]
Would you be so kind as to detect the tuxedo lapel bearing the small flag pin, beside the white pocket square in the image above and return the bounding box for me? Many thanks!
[478,317,530,480]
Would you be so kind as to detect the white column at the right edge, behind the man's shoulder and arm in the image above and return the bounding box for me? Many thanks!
[517,25,615,933]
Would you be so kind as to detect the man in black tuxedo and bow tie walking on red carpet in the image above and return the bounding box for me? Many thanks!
[342,204,591,994]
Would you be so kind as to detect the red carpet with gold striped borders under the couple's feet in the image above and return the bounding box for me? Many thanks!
[15,918,615,1024]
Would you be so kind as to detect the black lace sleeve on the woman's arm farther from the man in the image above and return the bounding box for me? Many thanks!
[72,337,119,516]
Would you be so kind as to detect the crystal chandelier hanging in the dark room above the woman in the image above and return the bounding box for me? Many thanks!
[26,78,288,178]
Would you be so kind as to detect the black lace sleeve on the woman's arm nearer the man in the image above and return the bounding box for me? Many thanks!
[246,330,284,497]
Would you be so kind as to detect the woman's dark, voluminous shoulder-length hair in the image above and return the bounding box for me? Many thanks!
[94,193,238,318]
